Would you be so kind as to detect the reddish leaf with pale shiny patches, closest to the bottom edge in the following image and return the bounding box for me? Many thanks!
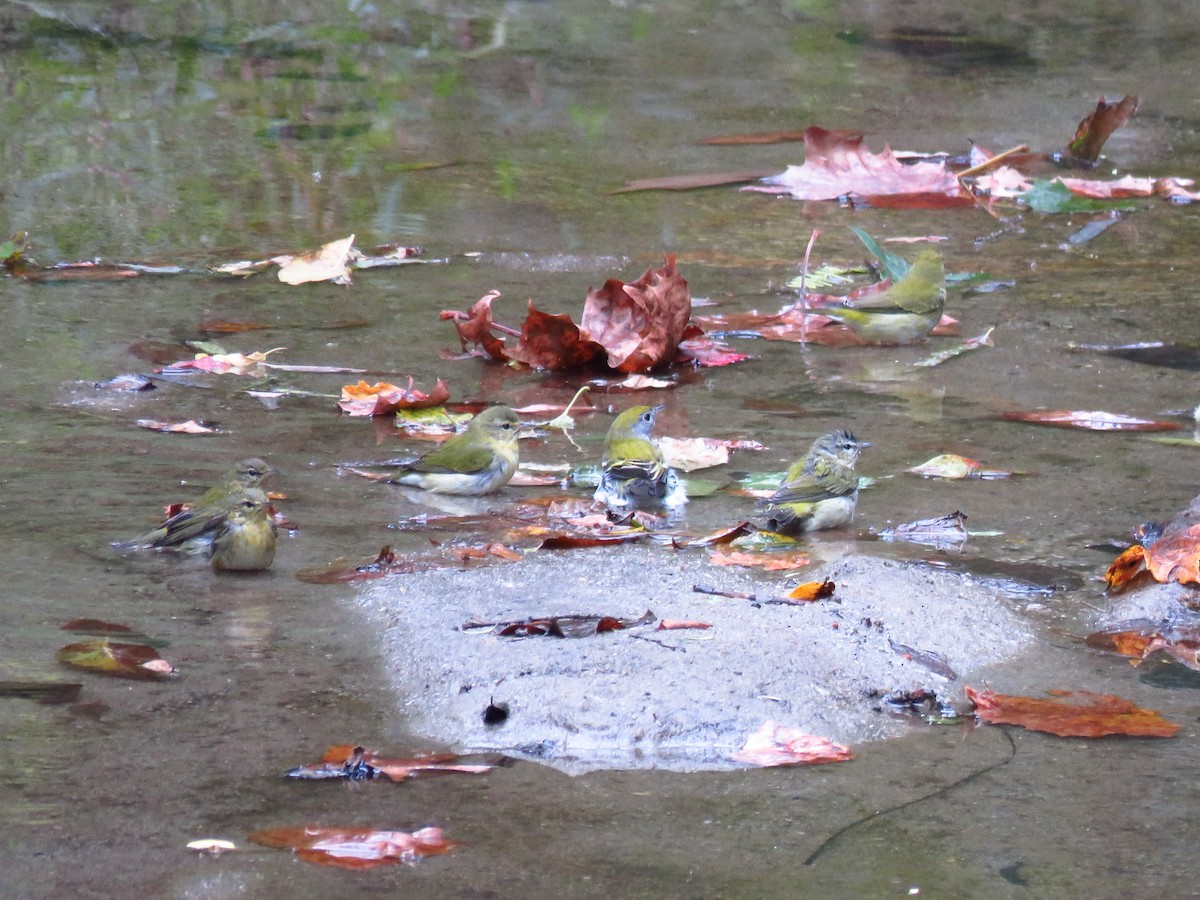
[247,826,458,869]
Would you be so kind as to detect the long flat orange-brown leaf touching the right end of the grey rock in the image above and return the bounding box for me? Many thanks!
[965,686,1180,738]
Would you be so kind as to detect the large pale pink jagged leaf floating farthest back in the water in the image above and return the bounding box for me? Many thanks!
[742,126,974,209]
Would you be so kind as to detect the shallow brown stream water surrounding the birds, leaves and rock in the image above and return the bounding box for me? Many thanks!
[0,2,1200,896]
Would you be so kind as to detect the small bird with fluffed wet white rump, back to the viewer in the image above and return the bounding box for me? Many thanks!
[594,407,688,509]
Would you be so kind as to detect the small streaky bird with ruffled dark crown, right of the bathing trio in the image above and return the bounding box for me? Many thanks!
[760,428,870,534]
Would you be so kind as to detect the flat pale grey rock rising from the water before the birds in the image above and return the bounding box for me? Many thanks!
[361,546,1033,774]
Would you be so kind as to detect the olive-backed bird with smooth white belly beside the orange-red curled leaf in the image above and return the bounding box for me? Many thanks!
[376,407,521,497]
